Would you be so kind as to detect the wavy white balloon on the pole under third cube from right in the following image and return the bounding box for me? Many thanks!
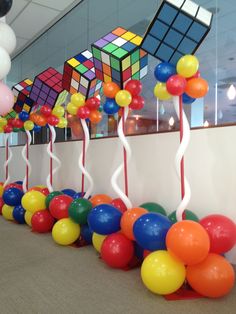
[78,119,94,198]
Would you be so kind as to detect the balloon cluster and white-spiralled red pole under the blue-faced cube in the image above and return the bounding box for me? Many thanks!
[154,55,208,221]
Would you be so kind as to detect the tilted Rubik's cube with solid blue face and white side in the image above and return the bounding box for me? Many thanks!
[141,0,212,64]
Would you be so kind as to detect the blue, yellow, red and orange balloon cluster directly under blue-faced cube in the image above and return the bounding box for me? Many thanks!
[154,55,208,104]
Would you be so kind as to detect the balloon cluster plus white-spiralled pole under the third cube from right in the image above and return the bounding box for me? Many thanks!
[67,93,102,198]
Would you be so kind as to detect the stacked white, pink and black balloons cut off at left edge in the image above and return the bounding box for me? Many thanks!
[0,0,16,116]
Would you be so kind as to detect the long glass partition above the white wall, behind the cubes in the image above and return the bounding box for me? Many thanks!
[2,0,236,145]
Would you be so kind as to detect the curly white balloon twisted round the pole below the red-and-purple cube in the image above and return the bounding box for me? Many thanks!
[46,125,61,193]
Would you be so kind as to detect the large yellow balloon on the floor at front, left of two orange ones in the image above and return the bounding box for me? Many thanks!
[141,250,186,295]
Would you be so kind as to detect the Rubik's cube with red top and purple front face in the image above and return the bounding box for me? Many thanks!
[29,68,68,112]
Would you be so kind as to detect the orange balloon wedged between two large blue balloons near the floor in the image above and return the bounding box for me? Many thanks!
[120,207,148,240]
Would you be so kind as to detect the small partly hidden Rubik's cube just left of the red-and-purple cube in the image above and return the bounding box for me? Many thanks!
[12,79,34,113]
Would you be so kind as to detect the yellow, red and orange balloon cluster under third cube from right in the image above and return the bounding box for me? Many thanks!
[66,93,102,124]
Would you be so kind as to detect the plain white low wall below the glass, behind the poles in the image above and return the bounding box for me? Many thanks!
[0,127,236,263]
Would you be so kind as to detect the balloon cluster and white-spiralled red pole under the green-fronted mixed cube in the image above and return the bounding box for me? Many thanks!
[103,80,144,208]
